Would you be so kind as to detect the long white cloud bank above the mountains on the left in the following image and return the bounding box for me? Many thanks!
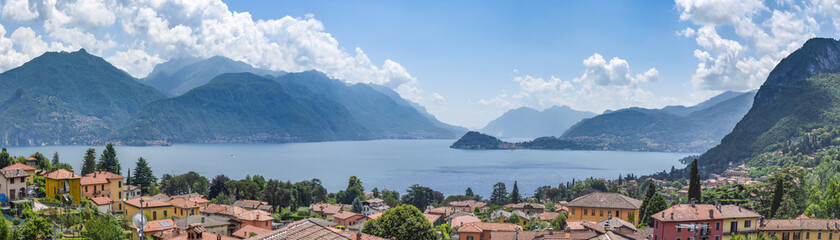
[0,0,424,101]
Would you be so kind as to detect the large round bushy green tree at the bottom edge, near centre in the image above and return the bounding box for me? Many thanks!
[362,205,437,240]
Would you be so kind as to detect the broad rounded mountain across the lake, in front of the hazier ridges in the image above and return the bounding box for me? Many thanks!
[114,73,372,143]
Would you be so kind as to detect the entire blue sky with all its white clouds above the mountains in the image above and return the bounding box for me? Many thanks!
[0,0,840,129]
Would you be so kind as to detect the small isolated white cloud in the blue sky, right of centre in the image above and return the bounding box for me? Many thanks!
[478,53,677,111]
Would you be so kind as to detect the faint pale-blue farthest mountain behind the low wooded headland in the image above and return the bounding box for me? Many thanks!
[480,106,597,138]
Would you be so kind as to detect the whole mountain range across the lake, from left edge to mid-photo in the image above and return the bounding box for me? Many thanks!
[0,50,466,146]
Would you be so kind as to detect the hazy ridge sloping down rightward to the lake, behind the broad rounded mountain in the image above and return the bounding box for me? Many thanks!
[276,71,457,139]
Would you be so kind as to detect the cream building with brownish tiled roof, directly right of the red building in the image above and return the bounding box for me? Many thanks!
[718,205,760,240]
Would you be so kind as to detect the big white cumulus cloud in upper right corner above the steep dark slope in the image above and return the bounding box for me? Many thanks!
[675,0,824,91]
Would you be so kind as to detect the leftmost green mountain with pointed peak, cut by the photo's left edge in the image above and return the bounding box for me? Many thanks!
[0,49,164,146]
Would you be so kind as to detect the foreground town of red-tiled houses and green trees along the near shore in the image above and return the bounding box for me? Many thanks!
[0,144,820,240]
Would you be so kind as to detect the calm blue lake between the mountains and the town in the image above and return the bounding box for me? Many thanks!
[3,140,691,198]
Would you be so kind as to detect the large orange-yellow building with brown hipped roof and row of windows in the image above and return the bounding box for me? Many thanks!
[565,192,642,224]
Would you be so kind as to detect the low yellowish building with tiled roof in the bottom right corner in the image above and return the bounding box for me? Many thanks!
[761,218,840,240]
